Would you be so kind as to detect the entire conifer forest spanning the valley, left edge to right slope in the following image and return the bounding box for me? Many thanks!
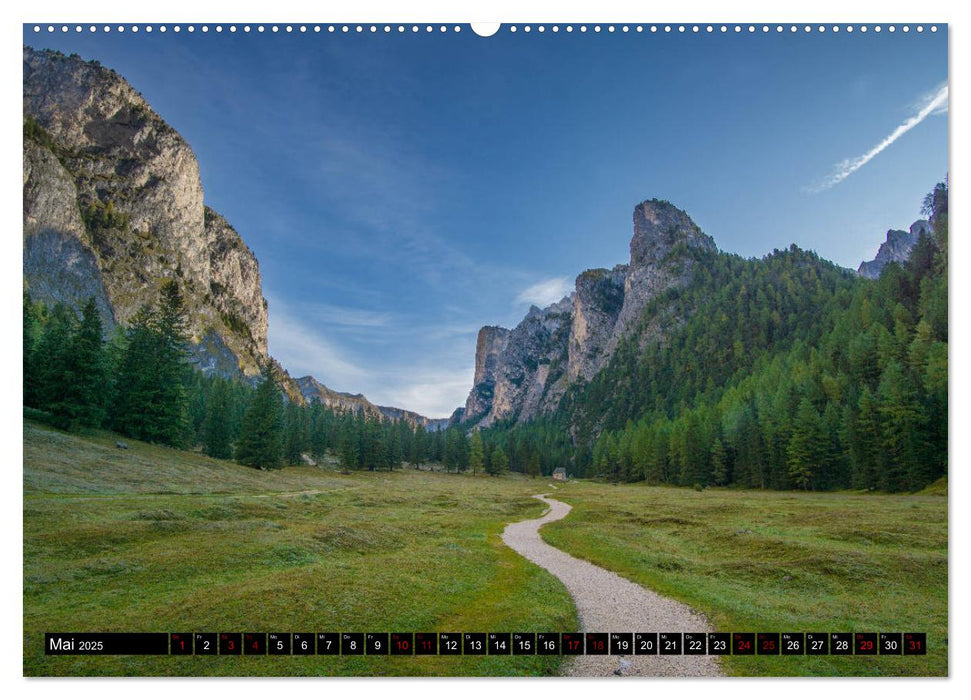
[23,183,948,491]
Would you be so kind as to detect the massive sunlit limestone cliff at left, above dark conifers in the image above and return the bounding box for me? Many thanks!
[23,47,268,377]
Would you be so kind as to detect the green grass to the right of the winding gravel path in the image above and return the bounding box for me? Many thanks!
[541,483,948,676]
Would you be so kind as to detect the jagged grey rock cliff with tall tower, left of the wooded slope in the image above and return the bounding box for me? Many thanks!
[461,199,715,427]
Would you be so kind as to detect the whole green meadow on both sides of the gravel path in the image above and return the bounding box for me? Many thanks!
[23,421,948,676]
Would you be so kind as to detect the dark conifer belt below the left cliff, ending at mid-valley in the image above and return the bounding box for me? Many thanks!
[23,282,478,473]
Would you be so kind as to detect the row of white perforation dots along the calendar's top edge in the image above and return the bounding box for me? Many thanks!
[34,24,937,34]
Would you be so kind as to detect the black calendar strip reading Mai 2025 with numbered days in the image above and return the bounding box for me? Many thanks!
[44,632,927,657]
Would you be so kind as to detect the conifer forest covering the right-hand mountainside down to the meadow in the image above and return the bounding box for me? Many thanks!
[484,182,948,491]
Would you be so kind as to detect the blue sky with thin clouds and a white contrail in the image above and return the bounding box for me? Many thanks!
[24,27,948,416]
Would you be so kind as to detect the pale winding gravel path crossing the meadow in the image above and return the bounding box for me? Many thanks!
[502,495,722,676]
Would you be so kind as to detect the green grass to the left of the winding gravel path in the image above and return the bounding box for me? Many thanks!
[24,422,578,675]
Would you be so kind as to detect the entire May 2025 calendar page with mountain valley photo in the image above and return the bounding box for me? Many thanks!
[22,8,950,690]
